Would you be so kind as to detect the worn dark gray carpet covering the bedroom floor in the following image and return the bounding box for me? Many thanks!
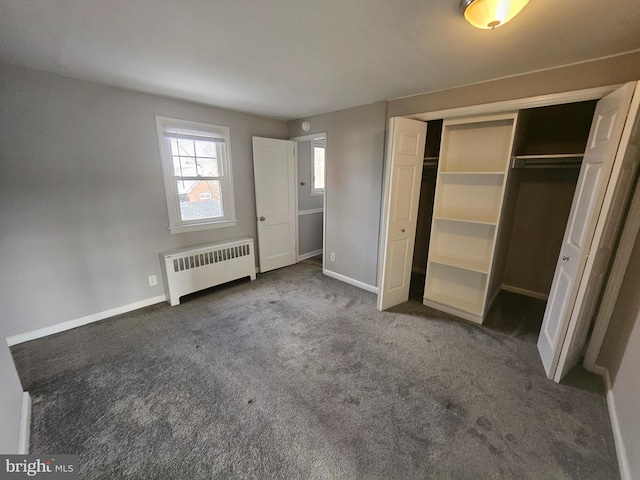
[12,262,619,480]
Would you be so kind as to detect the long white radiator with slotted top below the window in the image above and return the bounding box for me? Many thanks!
[160,238,256,306]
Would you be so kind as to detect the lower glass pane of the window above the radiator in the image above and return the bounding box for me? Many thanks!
[177,180,224,221]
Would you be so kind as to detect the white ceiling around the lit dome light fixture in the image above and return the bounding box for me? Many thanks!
[0,0,640,119]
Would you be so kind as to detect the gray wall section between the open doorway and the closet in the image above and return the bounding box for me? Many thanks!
[288,102,386,286]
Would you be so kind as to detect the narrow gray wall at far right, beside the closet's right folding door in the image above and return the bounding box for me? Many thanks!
[598,231,640,478]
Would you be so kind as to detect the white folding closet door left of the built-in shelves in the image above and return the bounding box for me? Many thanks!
[378,117,427,310]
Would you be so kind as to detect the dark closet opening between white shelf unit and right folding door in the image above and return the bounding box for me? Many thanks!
[484,100,597,341]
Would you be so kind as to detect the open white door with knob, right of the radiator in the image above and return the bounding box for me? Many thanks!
[253,137,296,273]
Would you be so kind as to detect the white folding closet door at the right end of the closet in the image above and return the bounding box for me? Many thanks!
[538,83,636,381]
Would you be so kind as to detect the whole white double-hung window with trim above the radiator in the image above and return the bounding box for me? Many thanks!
[156,117,237,233]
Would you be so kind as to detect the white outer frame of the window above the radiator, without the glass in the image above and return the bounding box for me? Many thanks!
[156,117,238,233]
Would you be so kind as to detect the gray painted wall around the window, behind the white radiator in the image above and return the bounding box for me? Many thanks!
[0,65,287,335]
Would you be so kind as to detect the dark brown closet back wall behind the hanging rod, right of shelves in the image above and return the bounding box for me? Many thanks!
[502,100,597,299]
